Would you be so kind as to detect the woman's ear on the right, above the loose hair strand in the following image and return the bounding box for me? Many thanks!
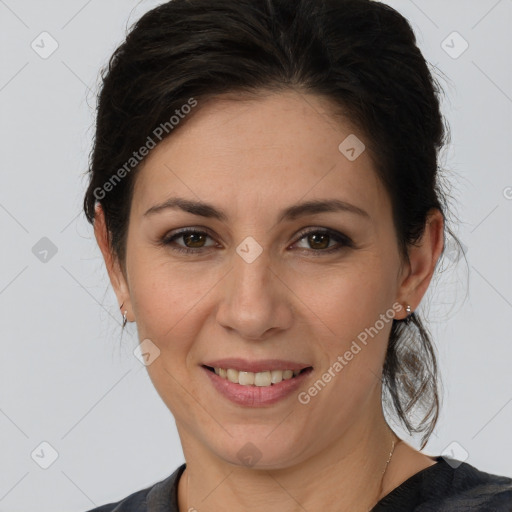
[396,208,444,320]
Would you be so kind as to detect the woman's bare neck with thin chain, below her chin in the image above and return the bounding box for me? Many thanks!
[178,408,399,512]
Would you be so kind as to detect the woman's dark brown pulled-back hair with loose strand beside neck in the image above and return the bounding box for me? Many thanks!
[84,0,458,448]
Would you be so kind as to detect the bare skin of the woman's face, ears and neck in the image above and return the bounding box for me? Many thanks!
[95,91,443,512]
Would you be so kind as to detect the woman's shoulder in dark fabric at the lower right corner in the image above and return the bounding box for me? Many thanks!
[372,456,512,512]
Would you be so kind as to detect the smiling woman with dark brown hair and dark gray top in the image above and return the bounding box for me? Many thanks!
[84,0,512,512]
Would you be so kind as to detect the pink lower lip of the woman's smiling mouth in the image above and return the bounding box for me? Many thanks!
[201,366,313,407]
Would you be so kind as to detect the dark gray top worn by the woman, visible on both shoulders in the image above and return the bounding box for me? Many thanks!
[87,456,512,512]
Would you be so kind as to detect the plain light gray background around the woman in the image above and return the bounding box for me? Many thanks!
[0,0,512,512]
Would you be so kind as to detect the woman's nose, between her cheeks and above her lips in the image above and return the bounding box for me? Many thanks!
[217,250,293,341]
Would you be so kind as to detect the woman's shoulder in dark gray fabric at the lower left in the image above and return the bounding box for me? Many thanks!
[83,464,185,512]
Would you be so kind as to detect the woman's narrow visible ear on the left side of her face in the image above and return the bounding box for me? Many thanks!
[94,204,131,321]
